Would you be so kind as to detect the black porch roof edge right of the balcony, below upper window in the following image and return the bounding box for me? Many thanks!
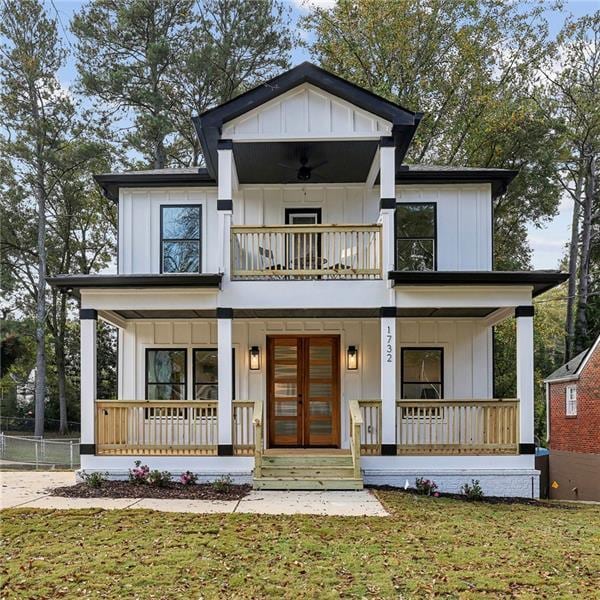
[388,271,569,297]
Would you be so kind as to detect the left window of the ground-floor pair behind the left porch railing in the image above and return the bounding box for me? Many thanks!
[146,348,187,400]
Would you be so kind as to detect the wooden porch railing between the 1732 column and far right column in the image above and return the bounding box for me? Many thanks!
[396,400,519,454]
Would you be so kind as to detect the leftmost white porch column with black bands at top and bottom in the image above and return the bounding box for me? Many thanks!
[79,308,98,454]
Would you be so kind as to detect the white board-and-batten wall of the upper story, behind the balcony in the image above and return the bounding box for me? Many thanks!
[119,184,492,276]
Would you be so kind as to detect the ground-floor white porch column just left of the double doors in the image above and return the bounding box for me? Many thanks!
[217,308,233,456]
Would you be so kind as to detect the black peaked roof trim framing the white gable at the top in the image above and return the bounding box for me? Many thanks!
[192,62,423,177]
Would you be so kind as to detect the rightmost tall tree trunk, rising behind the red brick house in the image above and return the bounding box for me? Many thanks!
[575,153,596,352]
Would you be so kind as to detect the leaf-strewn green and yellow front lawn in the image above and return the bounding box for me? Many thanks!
[0,492,600,600]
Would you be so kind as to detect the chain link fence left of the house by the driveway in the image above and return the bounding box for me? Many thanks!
[0,433,79,469]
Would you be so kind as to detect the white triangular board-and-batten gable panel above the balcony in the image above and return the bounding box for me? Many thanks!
[221,84,391,142]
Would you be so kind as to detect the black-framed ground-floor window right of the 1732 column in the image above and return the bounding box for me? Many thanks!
[402,348,444,400]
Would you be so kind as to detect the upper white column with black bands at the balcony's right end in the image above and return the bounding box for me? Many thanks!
[379,137,396,288]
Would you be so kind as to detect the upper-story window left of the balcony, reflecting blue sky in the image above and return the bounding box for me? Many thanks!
[160,204,202,273]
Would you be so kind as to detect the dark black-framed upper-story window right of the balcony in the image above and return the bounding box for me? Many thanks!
[395,202,437,271]
